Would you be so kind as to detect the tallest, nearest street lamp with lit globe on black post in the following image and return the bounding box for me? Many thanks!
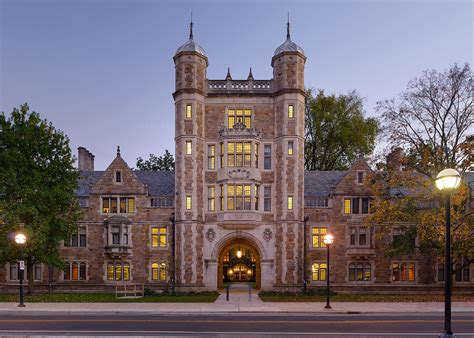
[435,169,461,337]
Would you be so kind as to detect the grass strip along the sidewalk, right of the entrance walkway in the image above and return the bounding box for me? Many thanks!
[258,291,474,302]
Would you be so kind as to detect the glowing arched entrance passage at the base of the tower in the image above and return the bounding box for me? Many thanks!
[217,238,261,289]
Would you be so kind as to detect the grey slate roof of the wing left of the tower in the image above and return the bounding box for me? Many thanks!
[76,171,174,197]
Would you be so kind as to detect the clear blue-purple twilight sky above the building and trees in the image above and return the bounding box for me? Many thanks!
[0,0,473,170]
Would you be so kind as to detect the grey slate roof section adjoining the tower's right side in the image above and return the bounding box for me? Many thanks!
[304,170,347,197]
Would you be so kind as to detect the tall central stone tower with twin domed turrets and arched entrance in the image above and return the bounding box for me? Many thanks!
[173,23,306,291]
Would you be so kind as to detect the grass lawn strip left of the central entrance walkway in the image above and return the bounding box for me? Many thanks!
[0,292,219,303]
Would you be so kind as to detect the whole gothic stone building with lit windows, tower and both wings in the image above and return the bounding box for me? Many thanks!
[0,27,474,292]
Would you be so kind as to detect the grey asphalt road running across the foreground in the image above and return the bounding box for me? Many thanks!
[0,313,474,337]
